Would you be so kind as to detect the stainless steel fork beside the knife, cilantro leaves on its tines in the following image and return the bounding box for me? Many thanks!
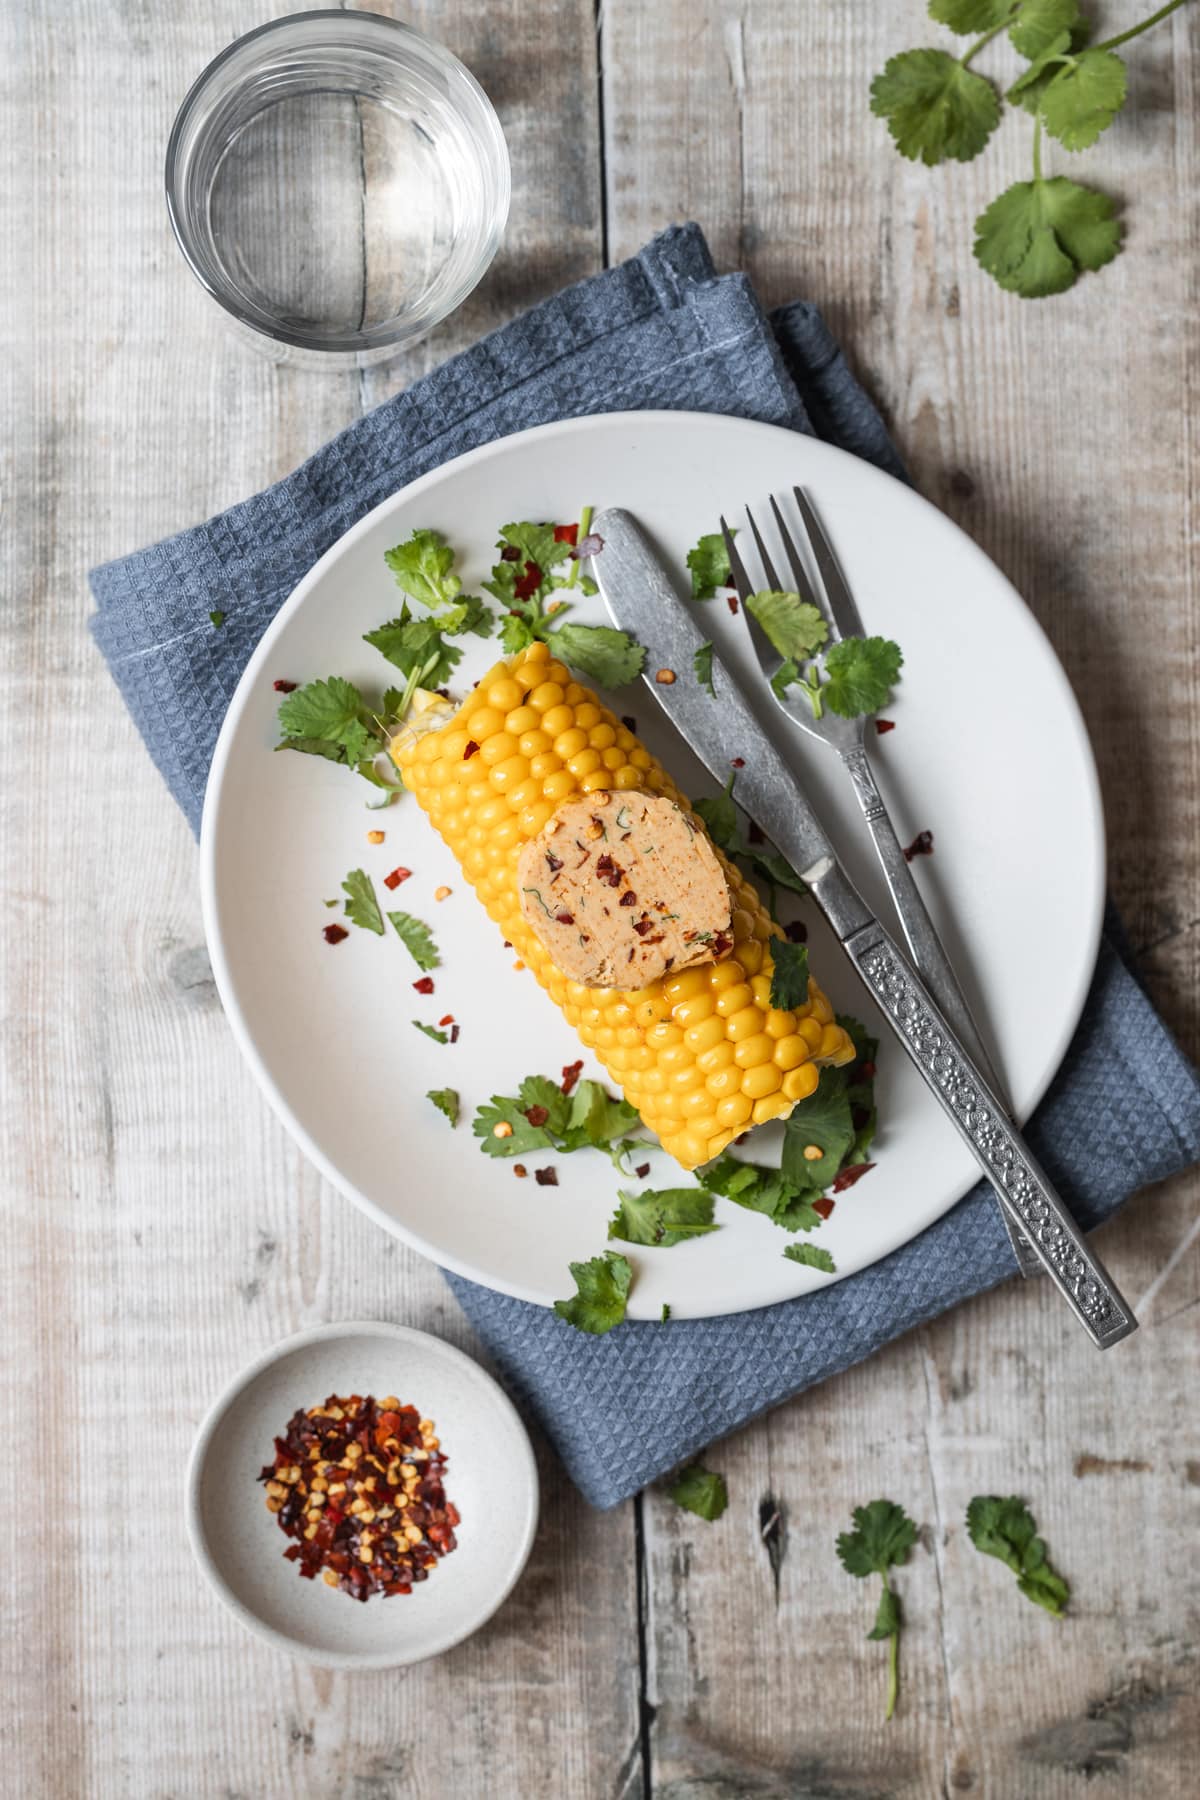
[721,488,1042,1274]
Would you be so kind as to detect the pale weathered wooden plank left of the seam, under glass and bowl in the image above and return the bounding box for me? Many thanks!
[0,0,640,1800]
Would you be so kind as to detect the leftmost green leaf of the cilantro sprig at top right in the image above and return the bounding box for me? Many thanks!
[871,50,1000,166]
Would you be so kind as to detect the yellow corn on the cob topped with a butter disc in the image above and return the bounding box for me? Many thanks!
[392,643,855,1168]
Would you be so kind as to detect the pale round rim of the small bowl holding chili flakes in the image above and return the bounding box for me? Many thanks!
[184,1319,542,1669]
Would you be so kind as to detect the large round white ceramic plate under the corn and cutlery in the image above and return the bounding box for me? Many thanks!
[201,412,1105,1318]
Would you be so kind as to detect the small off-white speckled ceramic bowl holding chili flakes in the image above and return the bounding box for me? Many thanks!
[187,1323,538,1669]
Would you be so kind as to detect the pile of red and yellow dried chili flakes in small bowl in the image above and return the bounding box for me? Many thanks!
[259,1393,459,1600]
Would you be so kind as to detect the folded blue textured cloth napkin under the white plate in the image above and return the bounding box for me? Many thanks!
[92,225,1200,1507]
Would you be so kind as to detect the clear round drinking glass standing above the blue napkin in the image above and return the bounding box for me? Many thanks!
[166,11,509,367]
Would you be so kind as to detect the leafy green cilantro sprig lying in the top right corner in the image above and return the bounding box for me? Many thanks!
[871,0,1186,299]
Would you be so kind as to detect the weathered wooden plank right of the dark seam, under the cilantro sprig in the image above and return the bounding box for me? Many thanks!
[603,0,1200,1800]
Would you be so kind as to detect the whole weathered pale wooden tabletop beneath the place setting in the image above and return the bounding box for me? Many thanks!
[0,0,1200,1800]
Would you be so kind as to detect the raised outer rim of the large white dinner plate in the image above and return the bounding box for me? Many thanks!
[200,409,1106,1318]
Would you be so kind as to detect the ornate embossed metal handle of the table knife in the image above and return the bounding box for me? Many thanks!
[844,920,1137,1350]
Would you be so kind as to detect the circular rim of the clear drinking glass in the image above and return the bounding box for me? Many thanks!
[162,7,513,364]
